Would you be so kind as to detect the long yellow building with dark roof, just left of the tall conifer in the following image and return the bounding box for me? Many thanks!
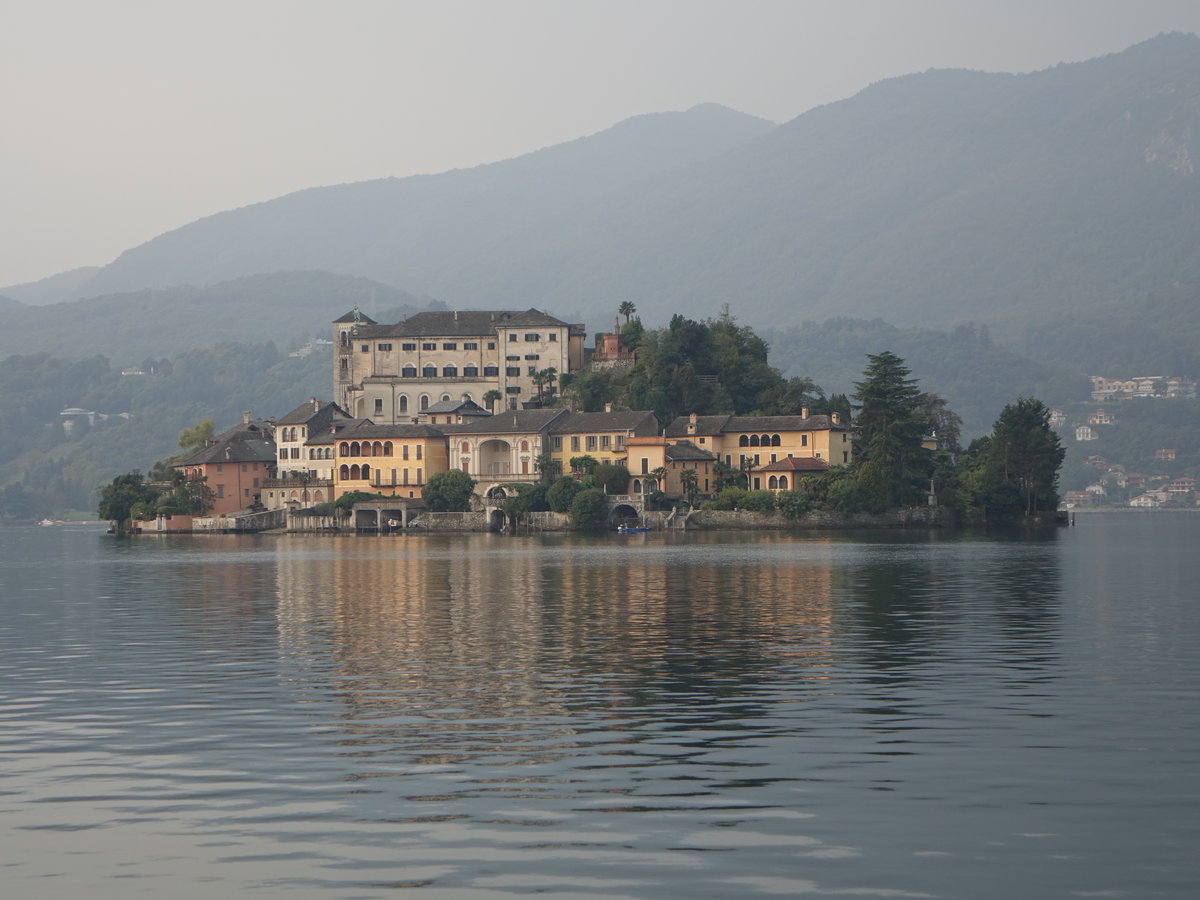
[666,409,853,468]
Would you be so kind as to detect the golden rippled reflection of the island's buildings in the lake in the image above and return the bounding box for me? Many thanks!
[277,534,834,758]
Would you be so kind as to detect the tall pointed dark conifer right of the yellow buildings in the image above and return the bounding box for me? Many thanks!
[854,350,930,512]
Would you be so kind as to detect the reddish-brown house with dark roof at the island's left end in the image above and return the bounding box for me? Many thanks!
[175,413,275,516]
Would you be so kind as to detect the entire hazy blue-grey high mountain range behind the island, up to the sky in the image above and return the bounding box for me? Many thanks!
[21,34,1200,367]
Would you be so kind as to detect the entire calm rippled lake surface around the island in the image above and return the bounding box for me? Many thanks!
[0,514,1200,900]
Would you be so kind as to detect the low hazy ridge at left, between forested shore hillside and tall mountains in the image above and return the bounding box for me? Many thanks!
[0,272,439,365]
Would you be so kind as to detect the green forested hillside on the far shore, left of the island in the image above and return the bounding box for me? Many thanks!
[0,343,331,518]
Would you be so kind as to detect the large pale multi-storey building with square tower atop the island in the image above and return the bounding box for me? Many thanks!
[334,310,586,424]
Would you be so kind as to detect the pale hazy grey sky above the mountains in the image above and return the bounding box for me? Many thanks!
[0,0,1200,286]
